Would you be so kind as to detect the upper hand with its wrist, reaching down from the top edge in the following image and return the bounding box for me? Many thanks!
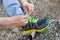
[19,0,34,15]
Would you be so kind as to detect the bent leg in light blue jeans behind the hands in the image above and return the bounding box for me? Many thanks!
[3,0,25,16]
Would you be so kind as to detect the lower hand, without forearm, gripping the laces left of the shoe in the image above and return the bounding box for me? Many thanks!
[11,15,28,26]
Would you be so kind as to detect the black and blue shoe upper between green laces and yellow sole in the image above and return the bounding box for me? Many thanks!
[22,19,50,30]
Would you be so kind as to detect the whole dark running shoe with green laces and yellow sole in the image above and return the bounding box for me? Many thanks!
[24,17,51,34]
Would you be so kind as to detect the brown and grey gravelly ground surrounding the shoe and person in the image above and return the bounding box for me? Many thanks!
[0,0,60,40]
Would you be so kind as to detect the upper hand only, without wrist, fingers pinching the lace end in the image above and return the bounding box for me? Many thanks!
[22,2,34,15]
